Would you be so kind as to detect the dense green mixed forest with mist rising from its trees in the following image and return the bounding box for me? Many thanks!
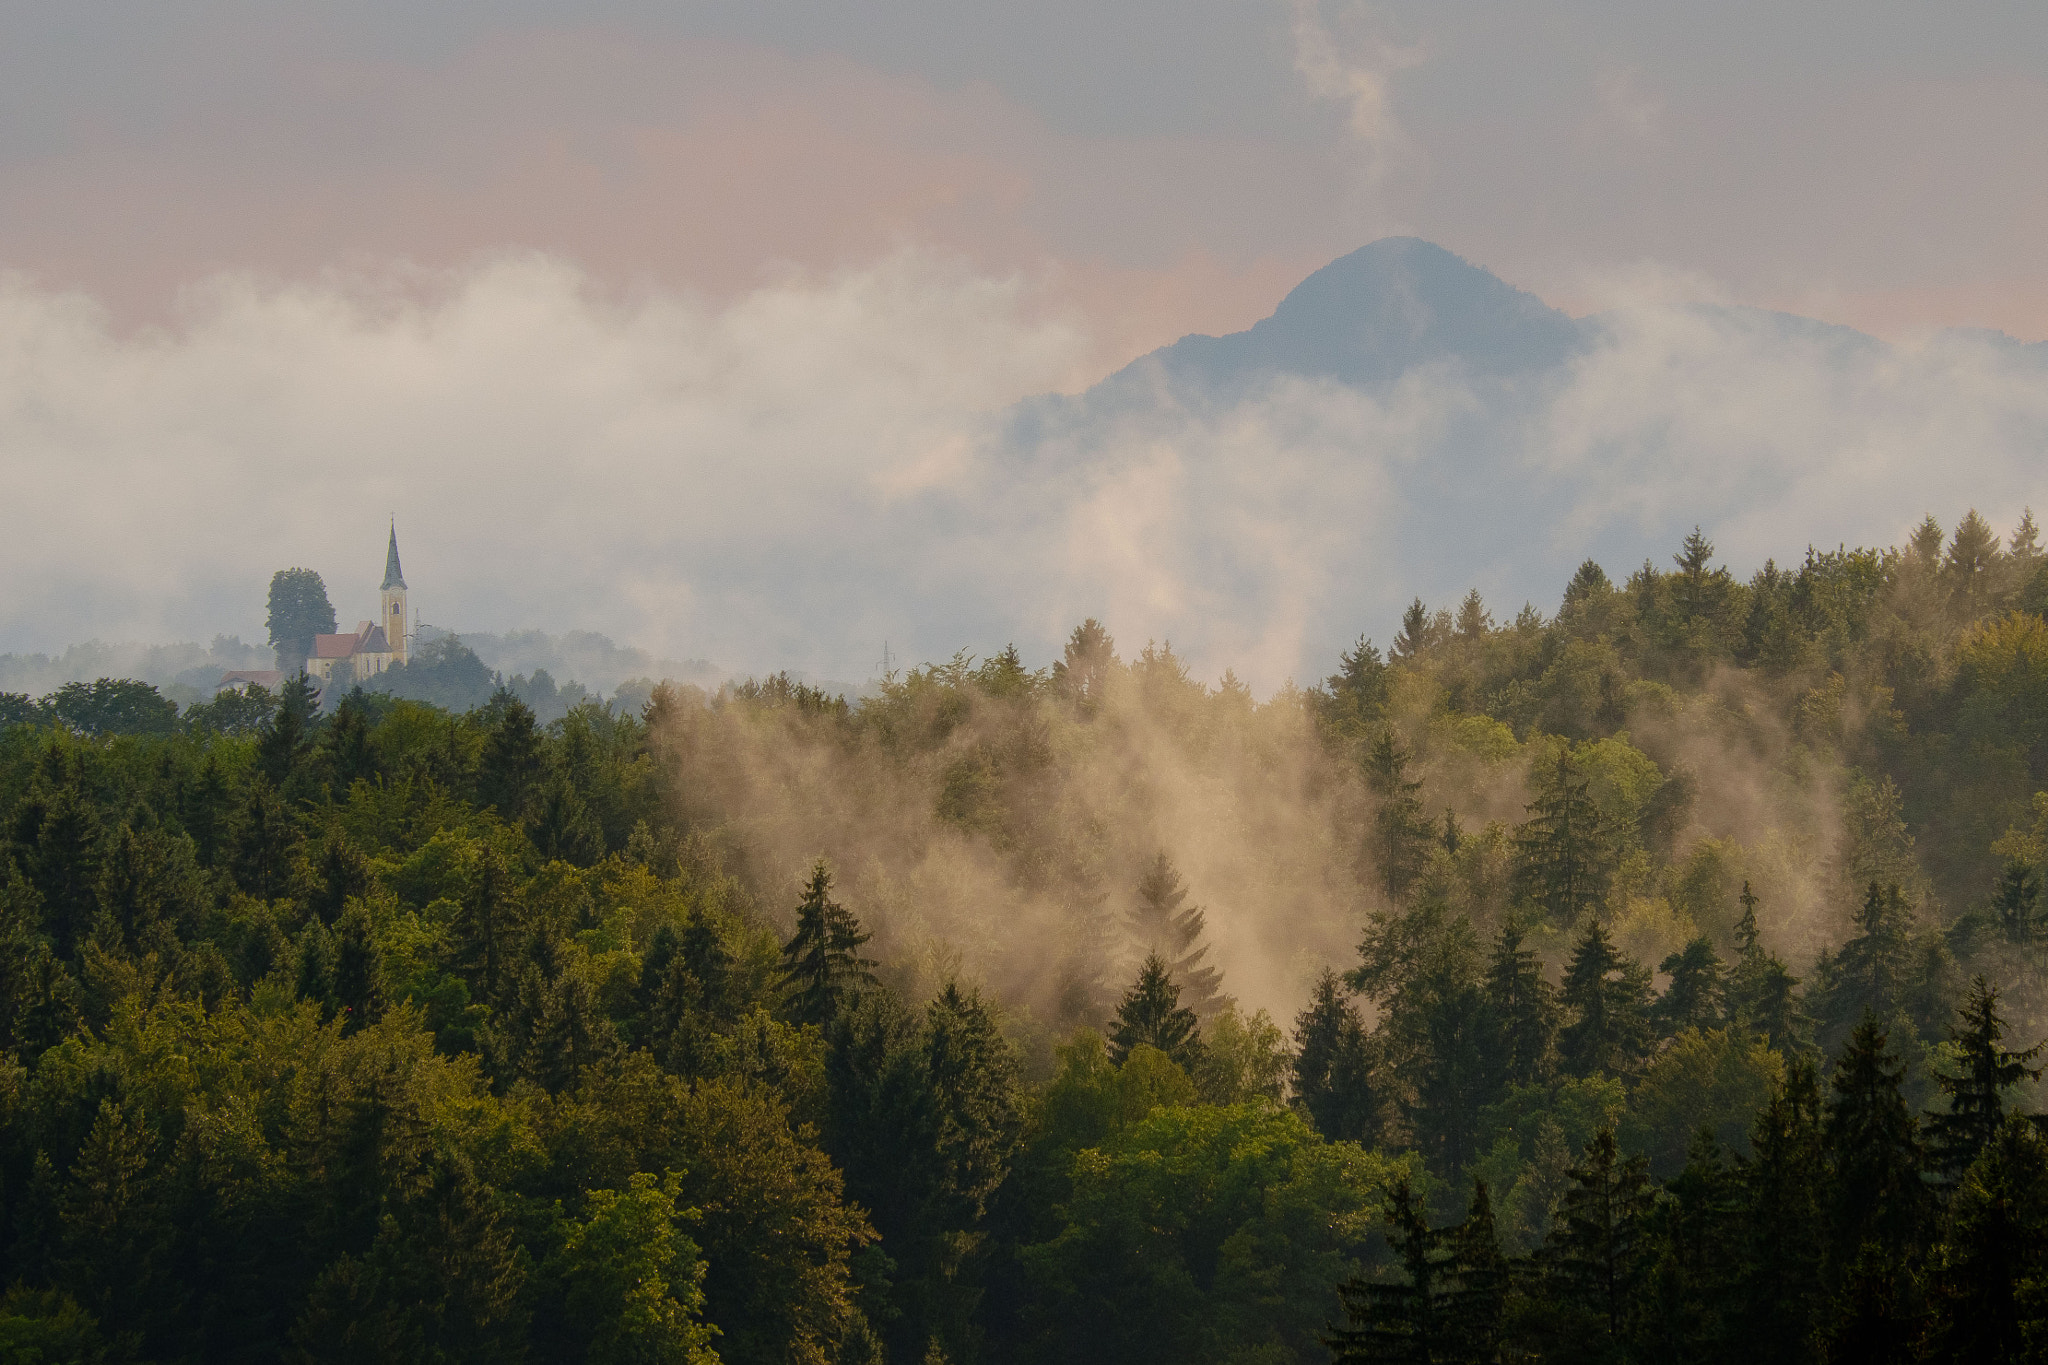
[0,512,2048,1365]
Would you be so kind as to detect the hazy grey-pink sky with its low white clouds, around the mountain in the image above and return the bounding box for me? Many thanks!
[0,0,2048,686]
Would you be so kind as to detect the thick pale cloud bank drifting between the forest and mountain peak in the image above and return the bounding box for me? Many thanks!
[0,252,2048,692]
